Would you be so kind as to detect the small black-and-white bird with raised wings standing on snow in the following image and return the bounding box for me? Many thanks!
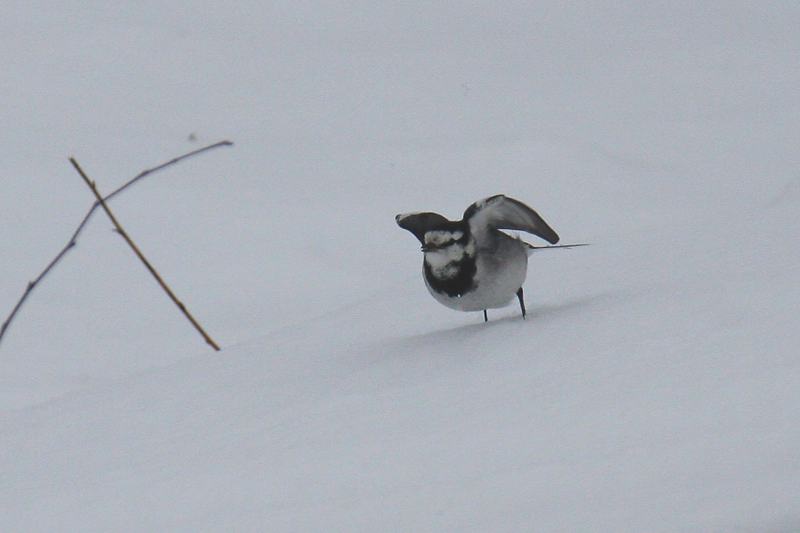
[395,194,559,322]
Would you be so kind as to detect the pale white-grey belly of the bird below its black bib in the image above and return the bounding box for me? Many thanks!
[422,239,528,311]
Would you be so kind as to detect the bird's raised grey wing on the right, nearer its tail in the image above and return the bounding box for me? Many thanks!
[464,194,558,244]
